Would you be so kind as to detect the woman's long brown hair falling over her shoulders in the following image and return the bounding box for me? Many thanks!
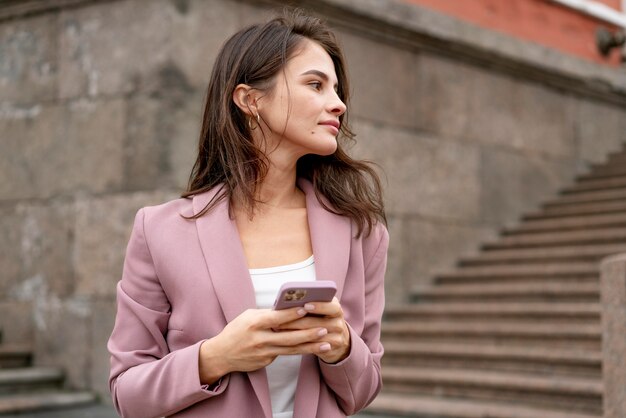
[182,9,386,236]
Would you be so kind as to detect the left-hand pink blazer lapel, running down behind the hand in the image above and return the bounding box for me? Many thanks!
[193,189,272,417]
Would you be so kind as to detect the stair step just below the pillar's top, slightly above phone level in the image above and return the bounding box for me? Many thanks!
[428,262,599,284]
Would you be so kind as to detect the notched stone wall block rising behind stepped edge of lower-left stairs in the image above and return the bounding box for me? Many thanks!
[34,298,93,389]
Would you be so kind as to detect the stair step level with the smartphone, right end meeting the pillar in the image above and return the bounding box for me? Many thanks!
[412,280,600,302]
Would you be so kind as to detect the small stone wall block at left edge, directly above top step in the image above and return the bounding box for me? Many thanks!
[0,300,34,344]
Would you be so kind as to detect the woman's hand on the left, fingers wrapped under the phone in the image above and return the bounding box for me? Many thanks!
[198,308,327,384]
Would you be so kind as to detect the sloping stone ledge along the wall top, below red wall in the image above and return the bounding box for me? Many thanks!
[262,0,626,106]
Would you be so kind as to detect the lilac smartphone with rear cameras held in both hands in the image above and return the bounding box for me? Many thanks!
[274,280,337,309]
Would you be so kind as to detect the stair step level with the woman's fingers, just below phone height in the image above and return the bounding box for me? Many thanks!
[385,302,600,328]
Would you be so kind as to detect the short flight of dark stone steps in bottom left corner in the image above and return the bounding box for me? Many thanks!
[0,344,96,416]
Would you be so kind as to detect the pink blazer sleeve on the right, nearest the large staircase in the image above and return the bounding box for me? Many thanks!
[319,224,389,415]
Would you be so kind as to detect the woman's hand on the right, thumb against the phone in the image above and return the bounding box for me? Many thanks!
[275,297,350,364]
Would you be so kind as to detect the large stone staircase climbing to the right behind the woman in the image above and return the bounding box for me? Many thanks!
[368,146,626,418]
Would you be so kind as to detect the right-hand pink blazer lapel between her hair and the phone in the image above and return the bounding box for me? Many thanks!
[298,179,352,299]
